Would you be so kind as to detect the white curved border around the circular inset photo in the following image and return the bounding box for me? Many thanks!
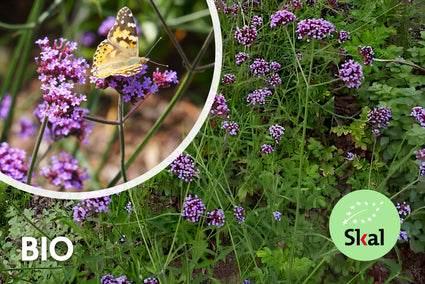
[0,0,223,199]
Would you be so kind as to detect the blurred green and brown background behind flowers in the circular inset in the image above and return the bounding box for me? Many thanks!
[0,0,214,190]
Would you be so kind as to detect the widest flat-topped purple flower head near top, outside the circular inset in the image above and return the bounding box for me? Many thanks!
[296,19,335,41]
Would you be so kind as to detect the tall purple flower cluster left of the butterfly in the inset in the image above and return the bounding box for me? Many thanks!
[34,37,93,144]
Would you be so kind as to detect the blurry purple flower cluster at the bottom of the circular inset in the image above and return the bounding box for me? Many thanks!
[40,153,89,189]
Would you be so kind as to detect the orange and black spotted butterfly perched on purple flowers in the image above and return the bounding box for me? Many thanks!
[92,7,149,78]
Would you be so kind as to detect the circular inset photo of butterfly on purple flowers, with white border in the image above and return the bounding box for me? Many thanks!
[0,1,222,199]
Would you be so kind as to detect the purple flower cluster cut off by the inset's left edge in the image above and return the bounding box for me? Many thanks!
[0,142,29,182]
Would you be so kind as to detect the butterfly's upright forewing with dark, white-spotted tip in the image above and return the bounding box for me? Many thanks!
[108,7,139,57]
